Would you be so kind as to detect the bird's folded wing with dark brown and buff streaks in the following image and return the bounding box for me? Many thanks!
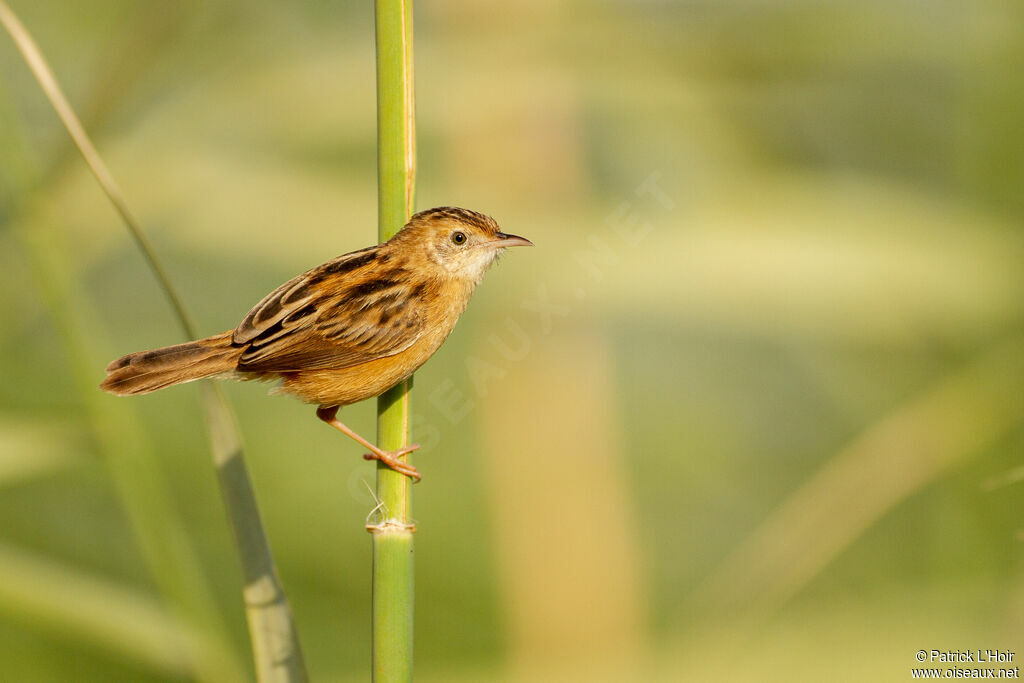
[232,247,426,372]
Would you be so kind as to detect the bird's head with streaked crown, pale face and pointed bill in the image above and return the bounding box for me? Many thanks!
[391,207,534,284]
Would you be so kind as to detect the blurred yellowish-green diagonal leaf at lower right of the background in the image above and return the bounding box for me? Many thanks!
[695,337,1024,617]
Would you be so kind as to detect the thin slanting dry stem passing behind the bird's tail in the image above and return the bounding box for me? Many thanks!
[0,0,307,683]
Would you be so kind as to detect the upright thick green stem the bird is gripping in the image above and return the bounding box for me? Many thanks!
[369,0,416,683]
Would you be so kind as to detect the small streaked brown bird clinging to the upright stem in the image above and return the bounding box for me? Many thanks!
[99,207,532,480]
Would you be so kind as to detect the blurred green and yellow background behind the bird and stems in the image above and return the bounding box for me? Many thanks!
[0,0,1024,681]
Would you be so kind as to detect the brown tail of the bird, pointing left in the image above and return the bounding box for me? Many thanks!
[99,331,245,396]
